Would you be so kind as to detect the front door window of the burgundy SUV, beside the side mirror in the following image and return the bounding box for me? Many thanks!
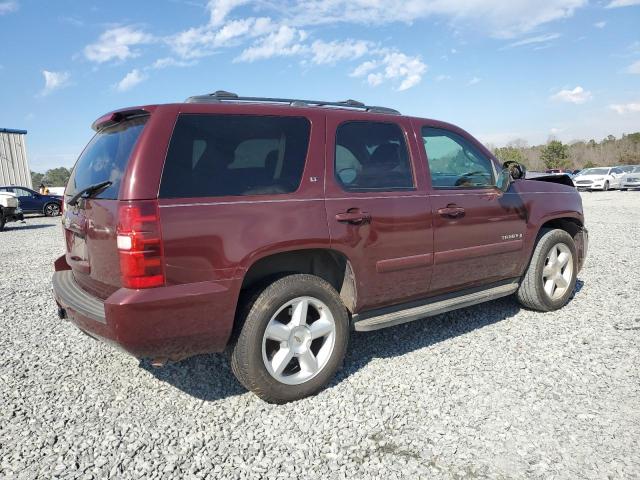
[422,127,495,188]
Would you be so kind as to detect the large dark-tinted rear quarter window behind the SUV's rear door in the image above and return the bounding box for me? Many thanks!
[160,115,310,198]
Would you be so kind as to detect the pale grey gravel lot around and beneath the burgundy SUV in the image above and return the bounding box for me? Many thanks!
[0,192,640,479]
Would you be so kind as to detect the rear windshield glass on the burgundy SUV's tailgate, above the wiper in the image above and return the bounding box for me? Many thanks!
[66,115,149,199]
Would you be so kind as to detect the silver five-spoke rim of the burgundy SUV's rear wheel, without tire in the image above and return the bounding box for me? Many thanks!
[262,297,336,385]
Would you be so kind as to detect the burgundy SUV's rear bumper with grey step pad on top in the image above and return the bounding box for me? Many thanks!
[53,262,237,360]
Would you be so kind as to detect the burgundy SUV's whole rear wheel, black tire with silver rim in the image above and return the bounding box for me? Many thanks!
[231,274,349,403]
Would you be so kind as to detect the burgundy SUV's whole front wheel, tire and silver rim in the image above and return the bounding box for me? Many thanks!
[517,229,578,312]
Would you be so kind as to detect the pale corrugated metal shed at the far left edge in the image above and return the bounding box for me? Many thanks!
[0,128,33,188]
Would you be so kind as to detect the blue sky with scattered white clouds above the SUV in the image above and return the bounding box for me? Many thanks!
[0,0,640,171]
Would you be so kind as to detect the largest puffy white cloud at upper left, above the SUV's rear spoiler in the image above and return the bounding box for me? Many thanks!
[84,26,154,63]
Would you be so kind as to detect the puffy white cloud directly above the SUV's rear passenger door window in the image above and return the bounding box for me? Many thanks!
[350,50,427,91]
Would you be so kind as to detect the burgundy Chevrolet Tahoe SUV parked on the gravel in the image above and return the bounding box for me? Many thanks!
[53,92,588,402]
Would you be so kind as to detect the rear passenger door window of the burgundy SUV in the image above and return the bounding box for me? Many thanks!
[334,122,414,192]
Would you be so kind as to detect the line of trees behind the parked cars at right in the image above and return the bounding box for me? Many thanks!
[490,132,640,171]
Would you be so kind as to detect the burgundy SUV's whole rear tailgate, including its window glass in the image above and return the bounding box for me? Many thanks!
[63,113,149,299]
